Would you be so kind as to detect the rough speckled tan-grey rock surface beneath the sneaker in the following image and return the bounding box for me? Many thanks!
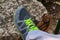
[0,0,47,40]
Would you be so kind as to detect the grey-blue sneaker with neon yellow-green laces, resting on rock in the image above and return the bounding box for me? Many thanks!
[14,5,38,40]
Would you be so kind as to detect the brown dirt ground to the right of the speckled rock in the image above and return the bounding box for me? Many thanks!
[39,0,60,34]
